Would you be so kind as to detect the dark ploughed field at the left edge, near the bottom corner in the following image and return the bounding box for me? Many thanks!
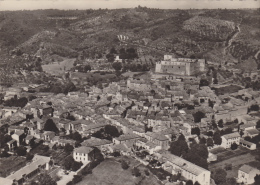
[0,156,26,177]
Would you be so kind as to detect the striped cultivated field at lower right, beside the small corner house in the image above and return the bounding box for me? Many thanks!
[209,148,255,178]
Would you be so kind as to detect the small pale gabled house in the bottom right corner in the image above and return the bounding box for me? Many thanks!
[237,164,260,184]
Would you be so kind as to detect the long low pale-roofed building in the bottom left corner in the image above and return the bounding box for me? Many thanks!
[6,155,50,185]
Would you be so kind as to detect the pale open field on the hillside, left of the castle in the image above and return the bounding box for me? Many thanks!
[42,59,75,75]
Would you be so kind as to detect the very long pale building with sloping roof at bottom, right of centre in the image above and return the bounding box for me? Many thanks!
[162,153,210,185]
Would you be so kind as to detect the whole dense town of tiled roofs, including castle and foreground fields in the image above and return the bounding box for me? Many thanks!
[0,52,260,185]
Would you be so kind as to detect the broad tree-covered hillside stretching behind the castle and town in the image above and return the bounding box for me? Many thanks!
[0,7,260,68]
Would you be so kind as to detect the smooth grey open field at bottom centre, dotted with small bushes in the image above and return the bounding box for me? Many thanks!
[78,157,160,185]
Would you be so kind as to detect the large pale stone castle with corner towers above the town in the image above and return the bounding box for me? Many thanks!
[155,55,205,76]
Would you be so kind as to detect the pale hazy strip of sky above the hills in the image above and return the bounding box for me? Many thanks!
[0,0,260,10]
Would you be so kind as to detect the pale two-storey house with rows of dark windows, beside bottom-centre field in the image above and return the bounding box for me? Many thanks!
[73,146,94,163]
